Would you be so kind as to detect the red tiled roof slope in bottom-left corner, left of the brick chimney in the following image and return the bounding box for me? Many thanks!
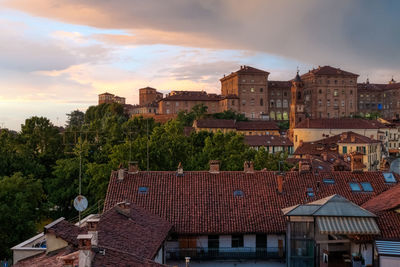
[13,246,78,267]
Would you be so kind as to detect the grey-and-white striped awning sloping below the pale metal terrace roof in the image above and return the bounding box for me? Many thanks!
[317,216,380,235]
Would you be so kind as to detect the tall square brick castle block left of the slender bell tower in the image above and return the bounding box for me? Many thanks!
[220,66,269,119]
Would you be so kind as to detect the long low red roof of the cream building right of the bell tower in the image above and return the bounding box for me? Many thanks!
[295,118,387,129]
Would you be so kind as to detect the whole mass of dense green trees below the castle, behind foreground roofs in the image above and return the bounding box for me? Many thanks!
[0,104,290,258]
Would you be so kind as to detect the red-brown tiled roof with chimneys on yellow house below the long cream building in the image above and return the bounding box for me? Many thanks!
[294,131,380,155]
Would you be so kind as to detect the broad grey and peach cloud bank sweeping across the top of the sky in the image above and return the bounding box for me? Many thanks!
[5,0,400,71]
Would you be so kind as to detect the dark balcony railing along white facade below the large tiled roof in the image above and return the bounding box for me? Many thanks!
[167,247,285,260]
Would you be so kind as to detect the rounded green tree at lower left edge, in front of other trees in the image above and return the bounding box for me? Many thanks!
[0,173,44,259]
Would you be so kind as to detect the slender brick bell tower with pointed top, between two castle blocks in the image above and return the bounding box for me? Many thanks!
[289,70,306,140]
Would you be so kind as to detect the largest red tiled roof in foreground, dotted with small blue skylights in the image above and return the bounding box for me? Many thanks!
[104,171,399,234]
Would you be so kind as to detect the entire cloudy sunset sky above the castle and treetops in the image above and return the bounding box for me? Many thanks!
[0,0,400,130]
